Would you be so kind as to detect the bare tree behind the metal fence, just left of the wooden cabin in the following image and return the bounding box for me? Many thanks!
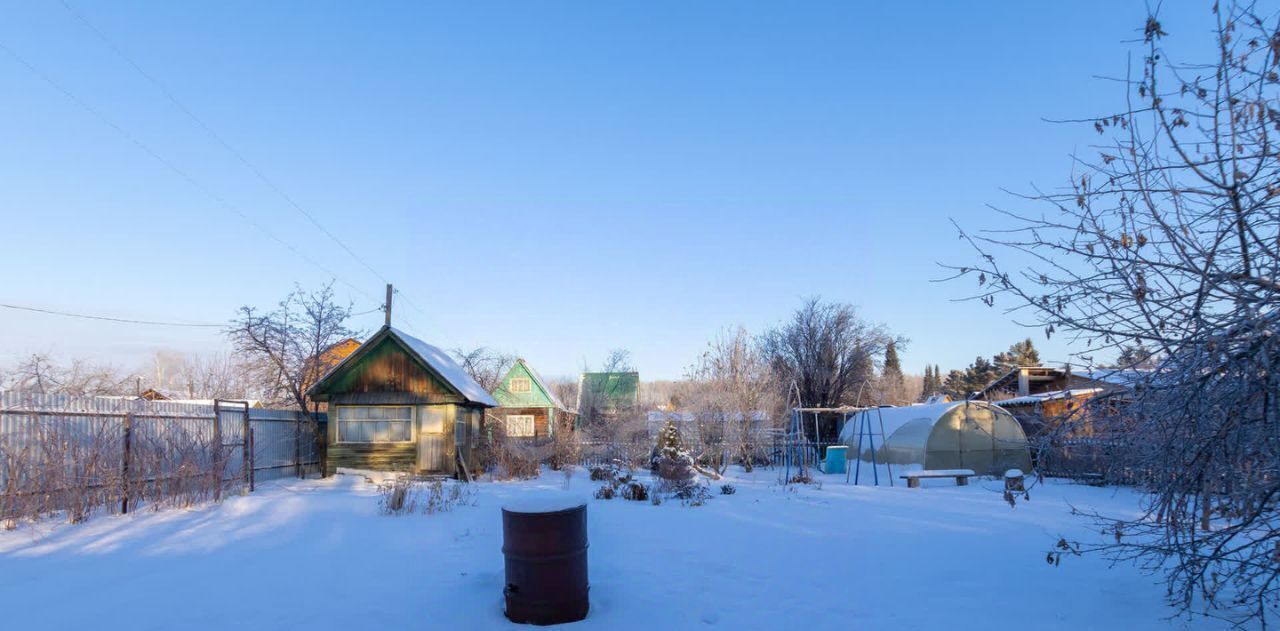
[227,283,353,413]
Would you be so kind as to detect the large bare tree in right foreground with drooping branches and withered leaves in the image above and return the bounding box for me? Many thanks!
[956,3,1280,626]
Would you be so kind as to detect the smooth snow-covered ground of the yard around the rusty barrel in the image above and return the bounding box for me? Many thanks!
[0,471,1216,631]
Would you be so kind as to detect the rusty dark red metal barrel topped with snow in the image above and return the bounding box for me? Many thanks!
[502,503,590,625]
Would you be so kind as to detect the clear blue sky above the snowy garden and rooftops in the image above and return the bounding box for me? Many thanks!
[0,0,1210,379]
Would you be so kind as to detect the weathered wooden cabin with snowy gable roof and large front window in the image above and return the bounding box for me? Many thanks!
[307,326,498,479]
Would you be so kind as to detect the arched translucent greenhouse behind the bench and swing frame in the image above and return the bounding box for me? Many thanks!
[840,401,1032,475]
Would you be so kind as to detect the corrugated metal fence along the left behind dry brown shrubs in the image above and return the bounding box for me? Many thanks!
[0,390,323,521]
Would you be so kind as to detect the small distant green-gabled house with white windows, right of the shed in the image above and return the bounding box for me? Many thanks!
[489,360,573,439]
